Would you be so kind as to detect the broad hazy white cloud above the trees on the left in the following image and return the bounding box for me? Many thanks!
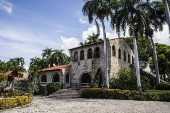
[0,26,60,67]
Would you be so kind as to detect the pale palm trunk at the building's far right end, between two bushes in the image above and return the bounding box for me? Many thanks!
[133,38,142,92]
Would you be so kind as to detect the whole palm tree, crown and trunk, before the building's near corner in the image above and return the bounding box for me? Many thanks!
[82,0,111,88]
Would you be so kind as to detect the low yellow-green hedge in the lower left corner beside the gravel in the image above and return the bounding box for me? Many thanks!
[0,94,32,109]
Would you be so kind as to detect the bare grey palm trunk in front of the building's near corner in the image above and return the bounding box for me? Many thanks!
[101,19,109,88]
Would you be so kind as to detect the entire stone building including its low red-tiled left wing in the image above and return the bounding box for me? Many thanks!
[39,38,134,88]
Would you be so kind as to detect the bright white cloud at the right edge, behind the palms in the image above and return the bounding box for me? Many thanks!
[154,25,170,45]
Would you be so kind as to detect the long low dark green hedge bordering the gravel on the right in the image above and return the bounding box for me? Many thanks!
[81,88,170,102]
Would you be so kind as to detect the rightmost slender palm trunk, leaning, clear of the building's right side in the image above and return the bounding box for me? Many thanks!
[149,37,160,85]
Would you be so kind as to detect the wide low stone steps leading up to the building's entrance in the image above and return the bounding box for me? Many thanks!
[47,89,80,99]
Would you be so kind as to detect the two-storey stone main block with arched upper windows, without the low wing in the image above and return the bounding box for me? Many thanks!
[70,38,134,87]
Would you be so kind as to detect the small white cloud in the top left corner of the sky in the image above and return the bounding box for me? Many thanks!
[0,0,13,14]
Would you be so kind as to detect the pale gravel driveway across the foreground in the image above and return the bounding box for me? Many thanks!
[0,97,170,113]
